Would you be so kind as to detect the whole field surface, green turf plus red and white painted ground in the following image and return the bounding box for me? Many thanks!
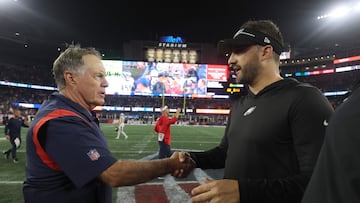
[0,124,225,203]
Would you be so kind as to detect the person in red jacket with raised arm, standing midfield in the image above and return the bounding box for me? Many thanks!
[154,106,181,159]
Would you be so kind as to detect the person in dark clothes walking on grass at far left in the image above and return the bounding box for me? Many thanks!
[3,109,29,163]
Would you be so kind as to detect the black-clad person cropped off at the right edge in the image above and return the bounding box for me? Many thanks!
[302,81,360,203]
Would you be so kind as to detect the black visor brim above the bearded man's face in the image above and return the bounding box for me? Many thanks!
[217,39,256,54]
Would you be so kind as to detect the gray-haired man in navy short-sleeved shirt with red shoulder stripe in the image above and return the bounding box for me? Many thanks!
[23,46,194,203]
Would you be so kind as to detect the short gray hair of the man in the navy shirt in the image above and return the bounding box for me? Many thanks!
[53,45,101,90]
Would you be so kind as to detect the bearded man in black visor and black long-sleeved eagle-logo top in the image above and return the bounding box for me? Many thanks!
[175,20,333,203]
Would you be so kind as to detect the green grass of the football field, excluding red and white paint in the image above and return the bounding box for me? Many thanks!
[0,124,225,203]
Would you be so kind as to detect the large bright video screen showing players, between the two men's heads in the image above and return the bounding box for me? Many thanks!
[102,60,228,96]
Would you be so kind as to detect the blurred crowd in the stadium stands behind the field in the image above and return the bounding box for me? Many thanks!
[0,61,360,125]
